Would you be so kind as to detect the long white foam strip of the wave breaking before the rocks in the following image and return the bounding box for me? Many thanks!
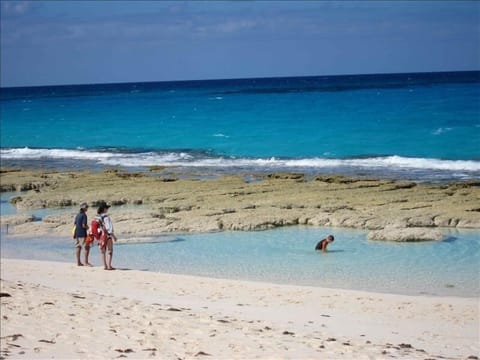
[0,148,480,172]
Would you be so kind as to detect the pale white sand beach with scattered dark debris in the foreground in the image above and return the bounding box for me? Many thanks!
[1,259,480,359]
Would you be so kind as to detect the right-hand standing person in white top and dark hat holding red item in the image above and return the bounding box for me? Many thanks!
[93,202,117,270]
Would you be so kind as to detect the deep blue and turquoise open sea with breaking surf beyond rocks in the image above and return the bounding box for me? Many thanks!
[0,71,480,182]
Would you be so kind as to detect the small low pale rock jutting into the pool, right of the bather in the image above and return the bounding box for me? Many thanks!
[368,227,444,242]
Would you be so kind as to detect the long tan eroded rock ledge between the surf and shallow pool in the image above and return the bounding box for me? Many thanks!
[0,169,480,241]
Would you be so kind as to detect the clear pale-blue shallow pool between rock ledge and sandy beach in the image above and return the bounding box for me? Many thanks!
[1,227,480,296]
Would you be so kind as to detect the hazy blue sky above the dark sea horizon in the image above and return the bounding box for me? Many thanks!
[0,0,480,87]
